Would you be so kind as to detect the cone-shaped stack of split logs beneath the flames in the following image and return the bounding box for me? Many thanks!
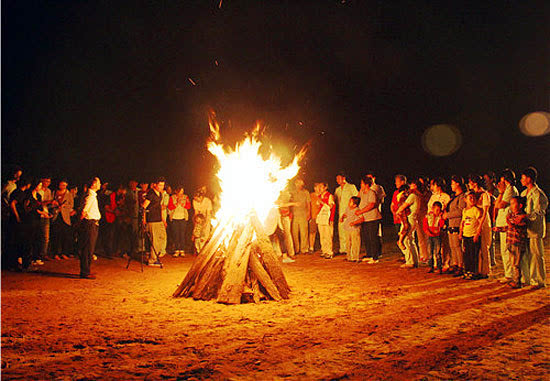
[173,216,290,304]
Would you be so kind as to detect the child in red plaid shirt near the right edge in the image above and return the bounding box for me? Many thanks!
[506,196,527,288]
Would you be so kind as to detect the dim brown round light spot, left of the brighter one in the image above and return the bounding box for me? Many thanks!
[422,124,462,156]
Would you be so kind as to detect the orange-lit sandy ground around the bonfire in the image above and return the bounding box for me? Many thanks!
[2,236,550,380]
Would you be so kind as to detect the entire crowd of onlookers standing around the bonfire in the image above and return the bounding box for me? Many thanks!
[2,167,548,288]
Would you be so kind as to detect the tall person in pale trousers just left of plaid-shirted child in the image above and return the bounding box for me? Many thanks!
[494,169,519,283]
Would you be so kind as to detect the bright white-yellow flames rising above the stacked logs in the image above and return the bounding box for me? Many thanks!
[208,115,304,236]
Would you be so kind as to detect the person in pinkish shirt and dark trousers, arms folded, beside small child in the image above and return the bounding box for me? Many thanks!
[355,176,382,263]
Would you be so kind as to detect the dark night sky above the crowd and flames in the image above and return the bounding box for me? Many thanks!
[2,0,550,193]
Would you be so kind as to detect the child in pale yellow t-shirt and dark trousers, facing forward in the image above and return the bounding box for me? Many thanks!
[459,192,483,280]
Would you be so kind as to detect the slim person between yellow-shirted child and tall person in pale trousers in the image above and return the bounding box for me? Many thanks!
[468,175,493,278]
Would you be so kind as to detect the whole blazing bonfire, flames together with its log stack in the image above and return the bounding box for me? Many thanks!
[174,115,303,304]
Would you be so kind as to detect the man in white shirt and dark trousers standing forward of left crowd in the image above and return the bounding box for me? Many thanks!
[80,177,101,279]
